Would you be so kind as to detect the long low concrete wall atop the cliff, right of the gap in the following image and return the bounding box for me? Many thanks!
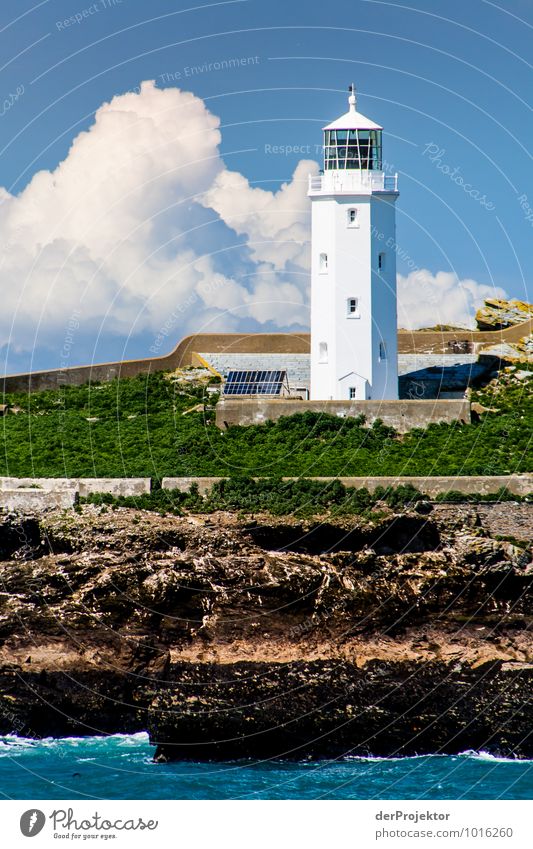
[161,475,533,497]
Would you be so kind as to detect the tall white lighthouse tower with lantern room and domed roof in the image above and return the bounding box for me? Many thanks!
[309,85,398,400]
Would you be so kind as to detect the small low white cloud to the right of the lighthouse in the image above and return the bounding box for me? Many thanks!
[398,268,507,330]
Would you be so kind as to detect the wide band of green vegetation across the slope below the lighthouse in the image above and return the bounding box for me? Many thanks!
[0,367,533,480]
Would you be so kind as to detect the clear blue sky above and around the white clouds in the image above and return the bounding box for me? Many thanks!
[0,0,533,371]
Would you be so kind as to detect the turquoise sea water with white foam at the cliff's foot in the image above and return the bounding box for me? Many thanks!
[0,734,533,799]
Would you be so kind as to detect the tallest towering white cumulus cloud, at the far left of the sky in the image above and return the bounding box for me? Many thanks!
[0,83,222,356]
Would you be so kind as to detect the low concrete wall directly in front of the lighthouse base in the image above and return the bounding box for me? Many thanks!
[216,398,470,433]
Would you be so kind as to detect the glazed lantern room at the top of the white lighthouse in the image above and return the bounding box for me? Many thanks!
[324,130,381,171]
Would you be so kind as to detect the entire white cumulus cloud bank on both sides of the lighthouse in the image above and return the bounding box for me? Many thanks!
[0,81,504,366]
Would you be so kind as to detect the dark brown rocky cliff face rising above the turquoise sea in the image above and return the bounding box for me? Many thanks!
[0,504,533,760]
